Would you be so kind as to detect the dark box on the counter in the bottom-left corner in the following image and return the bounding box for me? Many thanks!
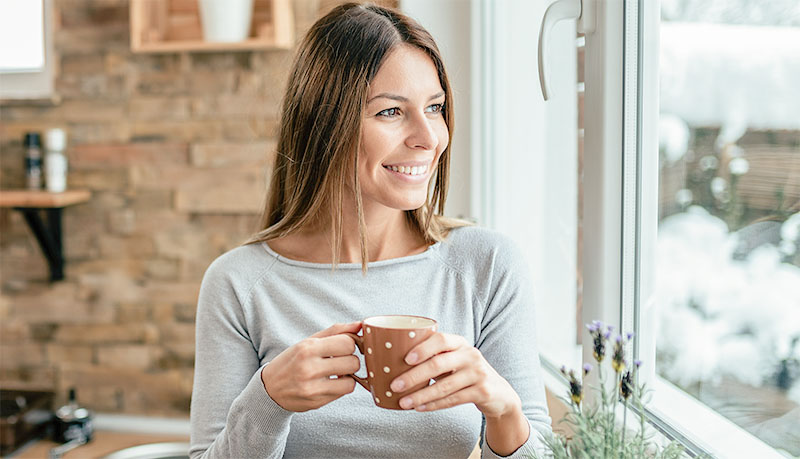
[0,389,54,456]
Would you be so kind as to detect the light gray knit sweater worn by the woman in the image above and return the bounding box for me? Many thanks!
[190,227,550,459]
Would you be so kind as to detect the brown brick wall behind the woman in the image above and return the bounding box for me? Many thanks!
[0,0,396,416]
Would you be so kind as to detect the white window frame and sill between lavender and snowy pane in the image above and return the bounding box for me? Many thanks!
[583,0,783,458]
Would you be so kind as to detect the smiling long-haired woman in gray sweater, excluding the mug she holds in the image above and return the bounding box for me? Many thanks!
[190,4,550,458]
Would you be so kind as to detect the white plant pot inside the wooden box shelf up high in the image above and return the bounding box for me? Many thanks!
[200,0,253,43]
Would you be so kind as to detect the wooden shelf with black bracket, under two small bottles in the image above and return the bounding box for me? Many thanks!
[0,190,91,281]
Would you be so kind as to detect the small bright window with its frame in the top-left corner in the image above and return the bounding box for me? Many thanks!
[0,0,55,100]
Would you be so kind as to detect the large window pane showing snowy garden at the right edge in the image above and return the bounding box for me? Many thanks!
[657,0,800,455]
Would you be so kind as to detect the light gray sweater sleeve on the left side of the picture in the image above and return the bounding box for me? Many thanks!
[189,260,292,459]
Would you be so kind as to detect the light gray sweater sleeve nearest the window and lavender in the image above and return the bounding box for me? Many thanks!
[476,237,552,458]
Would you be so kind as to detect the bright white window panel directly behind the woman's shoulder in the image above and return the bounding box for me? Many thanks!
[470,1,582,368]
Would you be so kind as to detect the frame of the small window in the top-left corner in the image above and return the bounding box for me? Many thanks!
[0,0,58,102]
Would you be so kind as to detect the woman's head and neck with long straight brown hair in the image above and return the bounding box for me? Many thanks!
[250,1,465,272]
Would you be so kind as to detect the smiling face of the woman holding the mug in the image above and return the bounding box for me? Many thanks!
[358,45,448,210]
